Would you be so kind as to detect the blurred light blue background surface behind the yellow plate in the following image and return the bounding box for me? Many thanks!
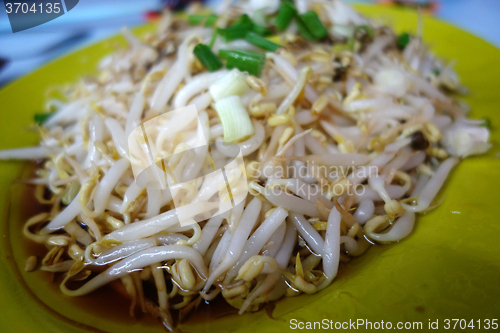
[0,0,500,87]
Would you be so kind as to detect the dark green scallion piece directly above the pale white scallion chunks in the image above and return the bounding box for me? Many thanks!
[219,50,266,76]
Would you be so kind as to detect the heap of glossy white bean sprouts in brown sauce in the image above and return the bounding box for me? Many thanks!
[0,0,489,330]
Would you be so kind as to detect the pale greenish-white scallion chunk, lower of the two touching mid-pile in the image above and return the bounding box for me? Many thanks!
[213,96,254,142]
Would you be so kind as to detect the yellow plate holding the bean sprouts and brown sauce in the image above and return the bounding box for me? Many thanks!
[0,6,500,333]
